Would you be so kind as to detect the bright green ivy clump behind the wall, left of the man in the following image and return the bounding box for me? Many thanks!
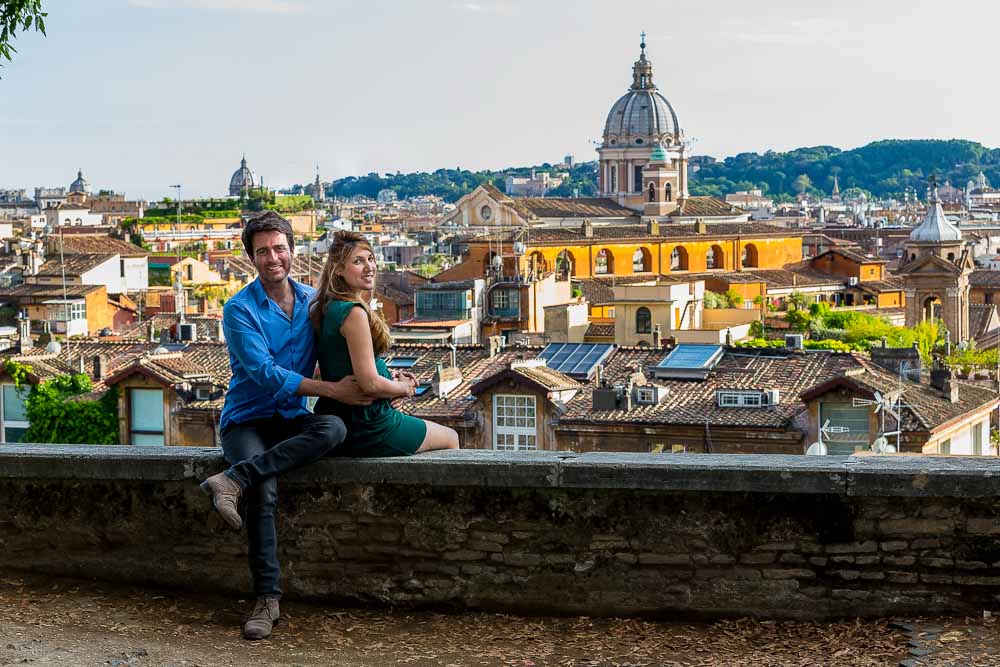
[23,373,119,445]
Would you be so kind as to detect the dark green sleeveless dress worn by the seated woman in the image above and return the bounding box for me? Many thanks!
[315,301,427,456]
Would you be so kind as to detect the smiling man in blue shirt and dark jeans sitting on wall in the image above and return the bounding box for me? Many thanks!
[201,211,372,639]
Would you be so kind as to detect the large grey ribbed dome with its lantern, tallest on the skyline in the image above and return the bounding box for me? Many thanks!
[604,40,683,147]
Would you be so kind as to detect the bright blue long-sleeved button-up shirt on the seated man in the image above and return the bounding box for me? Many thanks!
[219,278,316,429]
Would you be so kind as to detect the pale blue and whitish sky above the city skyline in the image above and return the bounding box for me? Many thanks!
[0,0,1000,200]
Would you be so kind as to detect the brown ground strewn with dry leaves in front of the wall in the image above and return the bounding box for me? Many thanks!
[0,575,1000,667]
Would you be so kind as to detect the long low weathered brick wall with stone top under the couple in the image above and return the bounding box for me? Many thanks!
[0,446,1000,619]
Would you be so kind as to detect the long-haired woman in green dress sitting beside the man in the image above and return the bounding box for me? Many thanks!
[309,232,458,456]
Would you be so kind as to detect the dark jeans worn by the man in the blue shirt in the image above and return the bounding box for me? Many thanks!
[222,414,347,597]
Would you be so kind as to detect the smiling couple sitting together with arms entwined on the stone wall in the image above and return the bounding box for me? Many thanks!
[201,211,458,639]
